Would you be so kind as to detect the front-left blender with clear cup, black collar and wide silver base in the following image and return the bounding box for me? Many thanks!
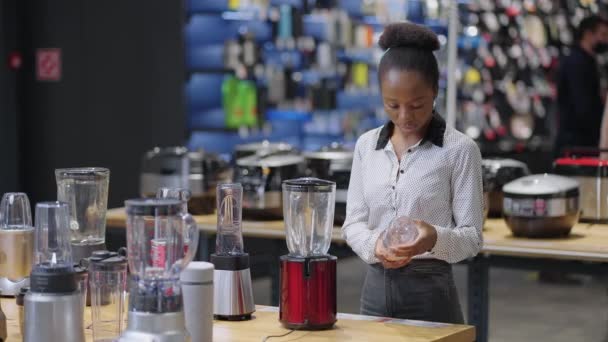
[24,202,85,342]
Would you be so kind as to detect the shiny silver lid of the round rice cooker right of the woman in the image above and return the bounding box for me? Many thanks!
[502,173,579,196]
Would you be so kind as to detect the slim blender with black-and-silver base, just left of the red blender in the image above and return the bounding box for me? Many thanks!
[210,183,255,321]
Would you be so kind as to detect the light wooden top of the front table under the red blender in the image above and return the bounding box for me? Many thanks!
[1,298,475,342]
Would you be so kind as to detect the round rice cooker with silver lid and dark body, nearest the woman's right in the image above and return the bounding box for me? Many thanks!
[502,174,580,238]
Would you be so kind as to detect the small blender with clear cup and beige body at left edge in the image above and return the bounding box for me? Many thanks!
[0,192,34,296]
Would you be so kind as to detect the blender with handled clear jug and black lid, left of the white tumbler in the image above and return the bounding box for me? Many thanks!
[118,198,198,342]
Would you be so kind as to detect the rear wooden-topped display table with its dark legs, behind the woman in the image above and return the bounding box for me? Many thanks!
[107,208,608,342]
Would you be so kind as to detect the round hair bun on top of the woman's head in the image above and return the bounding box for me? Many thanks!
[378,23,439,51]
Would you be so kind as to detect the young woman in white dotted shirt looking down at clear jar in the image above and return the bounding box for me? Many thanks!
[342,23,483,323]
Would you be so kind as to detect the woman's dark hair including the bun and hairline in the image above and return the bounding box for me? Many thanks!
[378,23,439,90]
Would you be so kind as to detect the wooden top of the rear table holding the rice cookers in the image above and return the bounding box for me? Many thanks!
[106,208,608,262]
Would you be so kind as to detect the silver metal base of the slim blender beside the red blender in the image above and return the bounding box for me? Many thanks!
[213,268,255,321]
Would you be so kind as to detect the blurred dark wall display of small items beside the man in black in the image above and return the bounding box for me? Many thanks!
[457,0,608,152]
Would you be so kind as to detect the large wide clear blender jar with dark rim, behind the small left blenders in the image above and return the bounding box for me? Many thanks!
[55,167,110,262]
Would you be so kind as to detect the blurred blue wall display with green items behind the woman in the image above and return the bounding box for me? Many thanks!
[185,0,450,153]
